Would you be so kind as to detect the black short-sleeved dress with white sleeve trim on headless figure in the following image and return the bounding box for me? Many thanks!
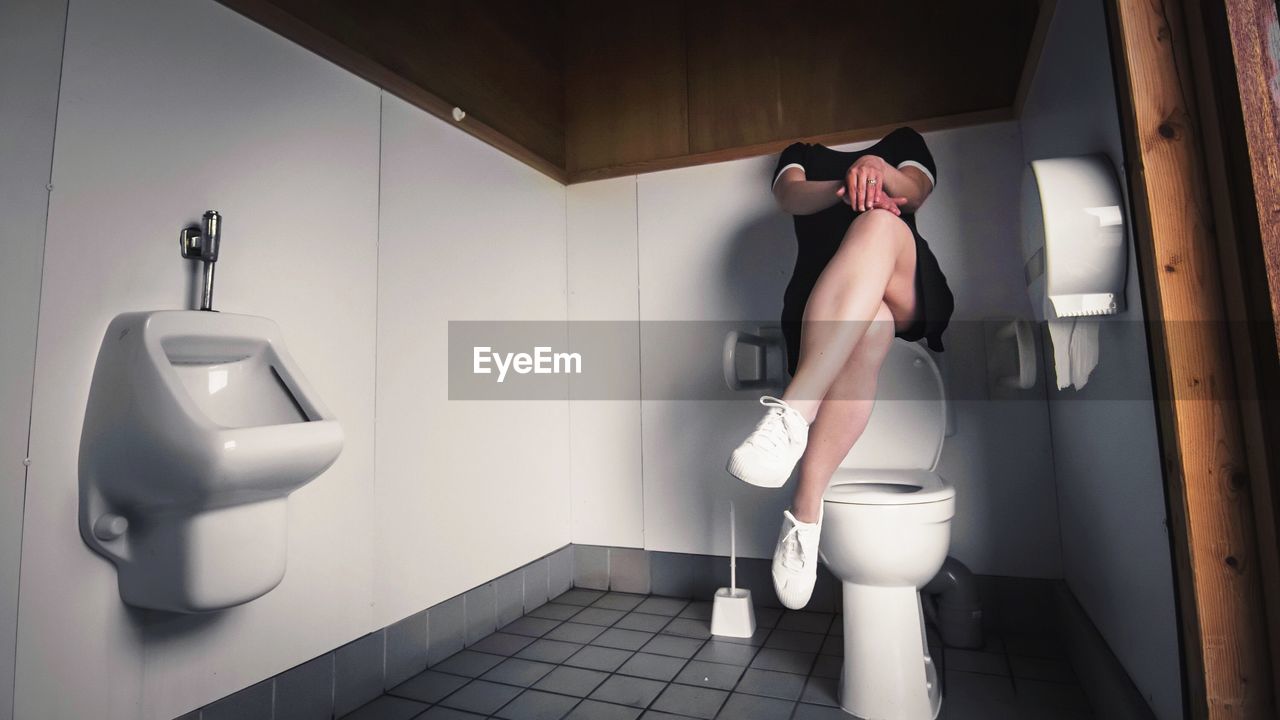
[773,127,955,373]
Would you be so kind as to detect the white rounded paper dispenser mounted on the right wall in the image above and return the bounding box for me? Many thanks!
[1021,155,1129,320]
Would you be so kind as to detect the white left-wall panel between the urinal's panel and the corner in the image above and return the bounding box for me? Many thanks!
[375,96,570,624]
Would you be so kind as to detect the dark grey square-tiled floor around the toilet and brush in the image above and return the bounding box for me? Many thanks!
[344,588,1092,720]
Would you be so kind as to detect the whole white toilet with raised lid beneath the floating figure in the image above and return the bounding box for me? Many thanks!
[819,341,955,720]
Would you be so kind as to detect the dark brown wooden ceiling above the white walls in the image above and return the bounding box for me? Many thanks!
[220,0,1052,182]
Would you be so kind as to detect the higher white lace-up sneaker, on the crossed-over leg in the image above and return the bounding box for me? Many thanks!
[726,396,809,488]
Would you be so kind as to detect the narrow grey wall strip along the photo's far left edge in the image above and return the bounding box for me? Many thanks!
[0,0,67,720]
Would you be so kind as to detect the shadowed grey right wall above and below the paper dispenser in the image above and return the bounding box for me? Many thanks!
[1021,1,1181,719]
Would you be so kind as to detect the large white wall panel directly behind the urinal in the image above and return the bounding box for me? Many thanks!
[17,0,378,719]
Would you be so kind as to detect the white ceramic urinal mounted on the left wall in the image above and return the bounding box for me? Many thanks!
[79,310,343,612]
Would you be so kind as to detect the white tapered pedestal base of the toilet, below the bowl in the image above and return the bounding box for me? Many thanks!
[840,583,942,720]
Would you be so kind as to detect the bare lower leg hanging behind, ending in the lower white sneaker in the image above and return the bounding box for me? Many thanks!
[791,302,895,523]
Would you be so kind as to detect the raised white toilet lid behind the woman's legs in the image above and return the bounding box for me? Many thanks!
[840,340,947,470]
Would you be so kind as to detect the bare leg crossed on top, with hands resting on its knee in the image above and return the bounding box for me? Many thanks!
[782,210,915,423]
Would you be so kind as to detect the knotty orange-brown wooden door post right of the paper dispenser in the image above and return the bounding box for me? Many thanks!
[1107,0,1275,720]
